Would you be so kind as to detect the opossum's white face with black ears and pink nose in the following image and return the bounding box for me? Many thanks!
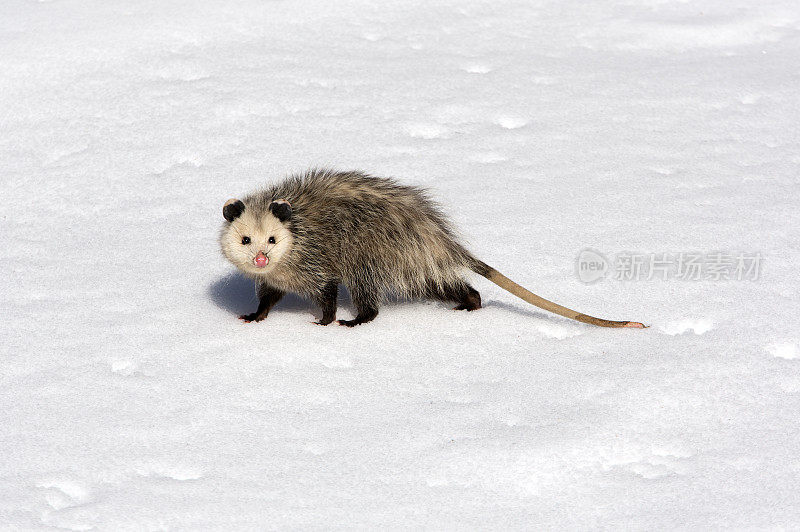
[220,199,293,275]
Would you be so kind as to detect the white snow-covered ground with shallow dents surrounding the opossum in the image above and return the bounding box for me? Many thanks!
[0,0,800,530]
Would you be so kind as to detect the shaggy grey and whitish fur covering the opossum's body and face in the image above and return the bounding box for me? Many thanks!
[220,170,487,323]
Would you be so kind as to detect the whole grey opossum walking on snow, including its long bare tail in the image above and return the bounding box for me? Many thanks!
[220,169,644,328]
